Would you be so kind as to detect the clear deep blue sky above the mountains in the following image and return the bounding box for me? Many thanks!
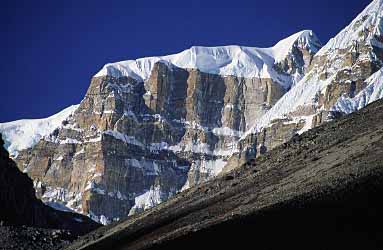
[0,0,371,122]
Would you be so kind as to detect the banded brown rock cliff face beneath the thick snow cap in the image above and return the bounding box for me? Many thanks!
[17,63,286,223]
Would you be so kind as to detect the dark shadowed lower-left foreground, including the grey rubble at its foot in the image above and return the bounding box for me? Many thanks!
[0,134,100,249]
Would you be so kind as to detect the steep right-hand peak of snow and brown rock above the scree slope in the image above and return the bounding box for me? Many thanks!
[224,0,383,171]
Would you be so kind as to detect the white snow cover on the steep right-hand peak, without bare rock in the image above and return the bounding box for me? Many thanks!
[242,0,383,139]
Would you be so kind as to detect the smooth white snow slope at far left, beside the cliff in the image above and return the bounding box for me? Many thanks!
[0,105,78,155]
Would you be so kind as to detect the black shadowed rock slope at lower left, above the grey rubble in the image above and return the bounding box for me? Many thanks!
[0,134,98,235]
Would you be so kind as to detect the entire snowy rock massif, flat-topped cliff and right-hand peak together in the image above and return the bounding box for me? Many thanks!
[0,0,383,227]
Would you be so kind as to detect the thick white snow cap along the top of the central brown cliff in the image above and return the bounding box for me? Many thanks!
[95,30,321,88]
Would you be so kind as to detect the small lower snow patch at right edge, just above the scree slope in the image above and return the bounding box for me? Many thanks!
[331,68,383,114]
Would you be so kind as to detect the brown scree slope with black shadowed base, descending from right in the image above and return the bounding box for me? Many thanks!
[67,98,383,250]
